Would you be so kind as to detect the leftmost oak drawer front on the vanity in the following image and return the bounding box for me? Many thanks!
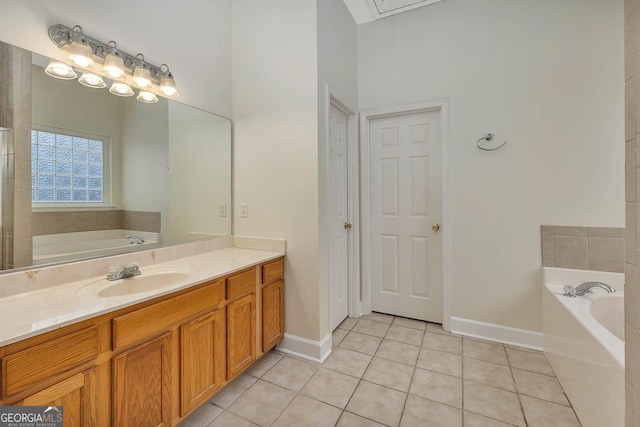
[1,326,98,398]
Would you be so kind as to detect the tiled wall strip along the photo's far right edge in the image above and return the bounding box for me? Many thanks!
[624,0,640,427]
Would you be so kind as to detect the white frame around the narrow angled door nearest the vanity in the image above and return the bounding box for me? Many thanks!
[324,85,363,332]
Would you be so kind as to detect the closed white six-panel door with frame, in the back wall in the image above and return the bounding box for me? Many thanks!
[361,100,450,329]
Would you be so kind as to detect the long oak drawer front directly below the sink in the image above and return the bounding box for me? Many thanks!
[113,281,224,350]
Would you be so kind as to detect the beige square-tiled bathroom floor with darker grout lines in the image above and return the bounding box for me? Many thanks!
[180,313,580,427]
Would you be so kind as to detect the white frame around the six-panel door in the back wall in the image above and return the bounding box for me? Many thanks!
[360,99,452,331]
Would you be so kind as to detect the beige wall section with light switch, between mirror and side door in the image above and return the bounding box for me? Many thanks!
[232,0,322,341]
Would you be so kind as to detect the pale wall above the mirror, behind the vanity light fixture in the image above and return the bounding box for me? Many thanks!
[0,0,231,117]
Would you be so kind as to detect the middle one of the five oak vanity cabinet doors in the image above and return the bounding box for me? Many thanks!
[180,308,227,417]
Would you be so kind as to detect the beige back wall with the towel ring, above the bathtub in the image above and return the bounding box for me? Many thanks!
[358,0,624,331]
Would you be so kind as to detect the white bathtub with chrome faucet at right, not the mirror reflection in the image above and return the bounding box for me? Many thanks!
[542,267,625,427]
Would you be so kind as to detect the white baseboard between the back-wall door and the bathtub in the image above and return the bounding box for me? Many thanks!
[451,317,542,350]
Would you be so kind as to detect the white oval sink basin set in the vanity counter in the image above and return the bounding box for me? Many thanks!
[97,268,192,297]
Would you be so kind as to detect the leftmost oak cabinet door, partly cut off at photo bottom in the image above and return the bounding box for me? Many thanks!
[18,368,97,427]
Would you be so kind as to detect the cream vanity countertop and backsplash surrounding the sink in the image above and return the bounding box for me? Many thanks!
[0,237,284,346]
